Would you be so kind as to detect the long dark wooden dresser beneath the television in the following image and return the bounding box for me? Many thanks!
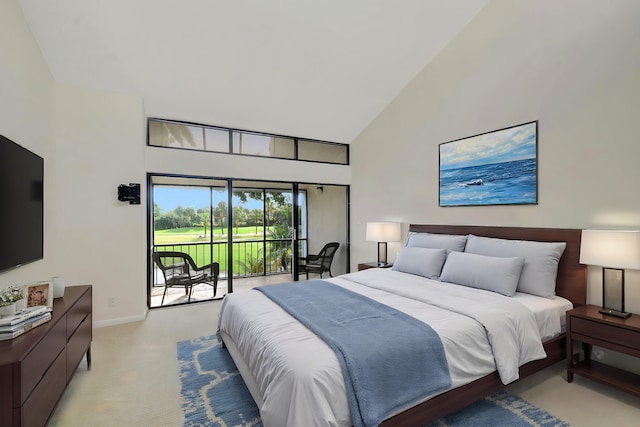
[0,285,92,427]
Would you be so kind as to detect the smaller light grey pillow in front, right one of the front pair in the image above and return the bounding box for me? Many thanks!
[440,252,524,297]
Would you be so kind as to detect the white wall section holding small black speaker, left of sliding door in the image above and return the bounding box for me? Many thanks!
[53,84,147,325]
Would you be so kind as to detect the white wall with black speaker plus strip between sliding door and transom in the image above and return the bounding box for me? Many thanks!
[55,84,351,326]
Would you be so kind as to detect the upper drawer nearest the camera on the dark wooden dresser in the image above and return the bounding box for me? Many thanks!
[16,316,67,404]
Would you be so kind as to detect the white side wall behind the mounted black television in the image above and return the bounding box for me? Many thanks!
[0,1,56,288]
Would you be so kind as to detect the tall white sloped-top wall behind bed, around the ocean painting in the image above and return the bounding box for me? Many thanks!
[351,0,640,372]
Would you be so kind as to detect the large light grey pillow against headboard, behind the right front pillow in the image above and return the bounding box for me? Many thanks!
[465,234,567,298]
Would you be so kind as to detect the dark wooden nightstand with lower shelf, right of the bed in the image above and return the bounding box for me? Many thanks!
[567,305,640,397]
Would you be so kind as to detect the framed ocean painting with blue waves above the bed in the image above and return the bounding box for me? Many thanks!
[439,121,538,206]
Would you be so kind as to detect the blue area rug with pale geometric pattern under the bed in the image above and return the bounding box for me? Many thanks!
[177,336,569,427]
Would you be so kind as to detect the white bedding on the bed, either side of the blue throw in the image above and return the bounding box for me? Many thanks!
[219,269,570,427]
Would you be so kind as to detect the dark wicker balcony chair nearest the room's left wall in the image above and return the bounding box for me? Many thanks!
[152,252,220,305]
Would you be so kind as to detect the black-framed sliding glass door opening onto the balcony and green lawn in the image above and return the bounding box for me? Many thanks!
[148,175,349,308]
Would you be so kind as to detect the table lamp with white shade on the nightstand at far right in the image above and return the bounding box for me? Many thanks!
[580,230,640,319]
